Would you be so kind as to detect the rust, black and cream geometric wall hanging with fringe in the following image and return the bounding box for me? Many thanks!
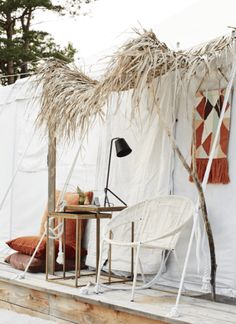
[191,89,231,184]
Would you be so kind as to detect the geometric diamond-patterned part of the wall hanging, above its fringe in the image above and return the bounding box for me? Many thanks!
[194,89,231,158]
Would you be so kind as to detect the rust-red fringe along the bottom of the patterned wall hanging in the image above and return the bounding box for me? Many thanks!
[189,158,230,184]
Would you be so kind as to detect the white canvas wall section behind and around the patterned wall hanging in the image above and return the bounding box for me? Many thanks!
[167,66,236,296]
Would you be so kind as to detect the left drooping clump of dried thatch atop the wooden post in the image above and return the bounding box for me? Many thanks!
[36,61,102,139]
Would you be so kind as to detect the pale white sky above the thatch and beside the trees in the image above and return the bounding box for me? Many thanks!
[38,0,236,75]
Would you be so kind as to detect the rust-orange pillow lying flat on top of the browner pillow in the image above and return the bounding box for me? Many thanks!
[6,236,86,259]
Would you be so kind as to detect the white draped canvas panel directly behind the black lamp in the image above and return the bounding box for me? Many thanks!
[86,79,173,274]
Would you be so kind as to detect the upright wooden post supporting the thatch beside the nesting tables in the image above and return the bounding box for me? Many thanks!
[47,131,56,274]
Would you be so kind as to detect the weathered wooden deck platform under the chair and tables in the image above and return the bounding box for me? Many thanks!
[0,261,236,324]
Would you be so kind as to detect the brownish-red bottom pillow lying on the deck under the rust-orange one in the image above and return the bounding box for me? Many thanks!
[4,252,81,273]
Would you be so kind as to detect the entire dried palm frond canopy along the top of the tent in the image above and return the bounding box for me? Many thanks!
[37,31,235,140]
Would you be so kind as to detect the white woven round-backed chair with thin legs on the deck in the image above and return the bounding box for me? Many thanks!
[95,195,194,301]
